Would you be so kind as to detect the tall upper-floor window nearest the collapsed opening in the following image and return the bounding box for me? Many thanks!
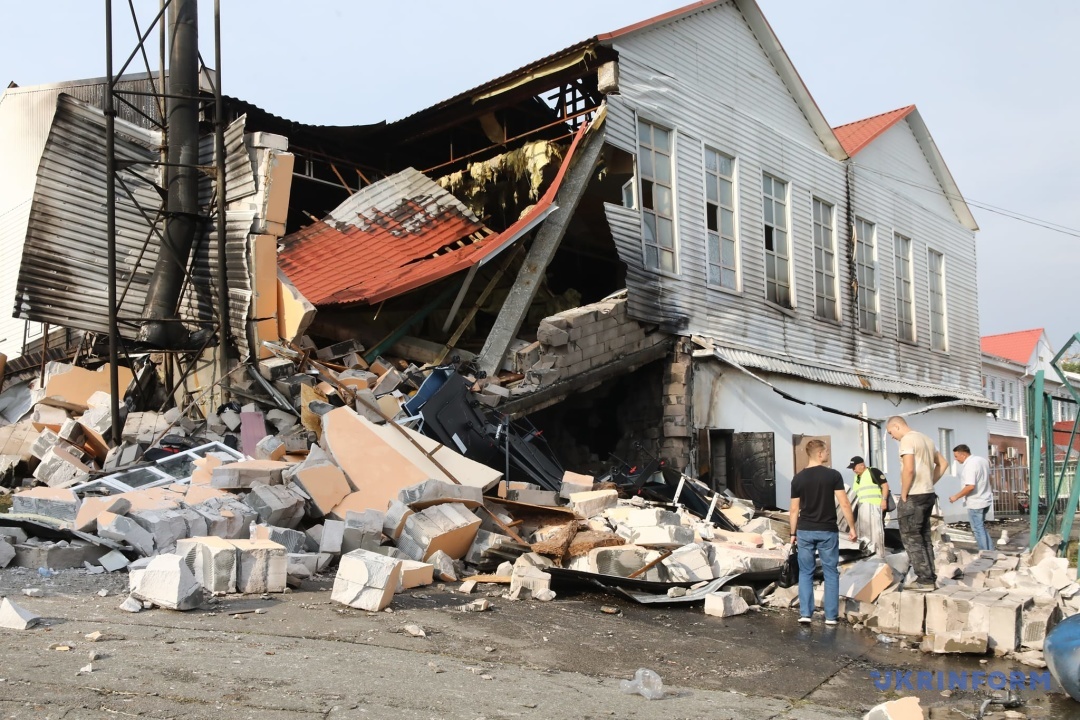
[637,120,677,272]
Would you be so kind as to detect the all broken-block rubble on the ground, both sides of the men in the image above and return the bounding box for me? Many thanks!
[0,334,1080,690]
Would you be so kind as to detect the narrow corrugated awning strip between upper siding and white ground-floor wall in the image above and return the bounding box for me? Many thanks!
[713,345,998,410]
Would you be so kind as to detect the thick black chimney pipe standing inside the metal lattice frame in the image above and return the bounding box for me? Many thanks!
[138,0,199,349]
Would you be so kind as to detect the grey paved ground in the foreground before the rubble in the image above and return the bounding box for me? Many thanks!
[0,568,1077,720]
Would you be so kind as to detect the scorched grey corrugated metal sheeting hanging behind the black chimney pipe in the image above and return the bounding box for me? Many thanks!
[15,95,254,352]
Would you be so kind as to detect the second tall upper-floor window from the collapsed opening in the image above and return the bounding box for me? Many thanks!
[705,148,739,290]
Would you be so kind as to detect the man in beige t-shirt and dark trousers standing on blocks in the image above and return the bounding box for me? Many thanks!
[886,416,948,590]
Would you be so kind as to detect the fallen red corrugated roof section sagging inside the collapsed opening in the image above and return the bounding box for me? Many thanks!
[278,125,586,305]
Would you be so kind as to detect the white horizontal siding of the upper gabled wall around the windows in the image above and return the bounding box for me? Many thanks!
[606,4,980,395]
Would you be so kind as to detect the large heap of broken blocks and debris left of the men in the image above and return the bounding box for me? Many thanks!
[0,342,786,615]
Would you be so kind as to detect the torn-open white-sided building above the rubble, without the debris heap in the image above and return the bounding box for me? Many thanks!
[0,2,990,507]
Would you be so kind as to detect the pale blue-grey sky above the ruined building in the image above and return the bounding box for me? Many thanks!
[0,0,1080,349]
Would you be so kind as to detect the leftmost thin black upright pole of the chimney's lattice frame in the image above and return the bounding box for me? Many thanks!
[104,0,123,446]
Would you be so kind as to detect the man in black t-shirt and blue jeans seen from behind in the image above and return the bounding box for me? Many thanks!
[791,439,858,625]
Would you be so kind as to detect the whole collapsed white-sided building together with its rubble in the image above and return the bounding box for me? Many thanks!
[0,0,1080,686]
